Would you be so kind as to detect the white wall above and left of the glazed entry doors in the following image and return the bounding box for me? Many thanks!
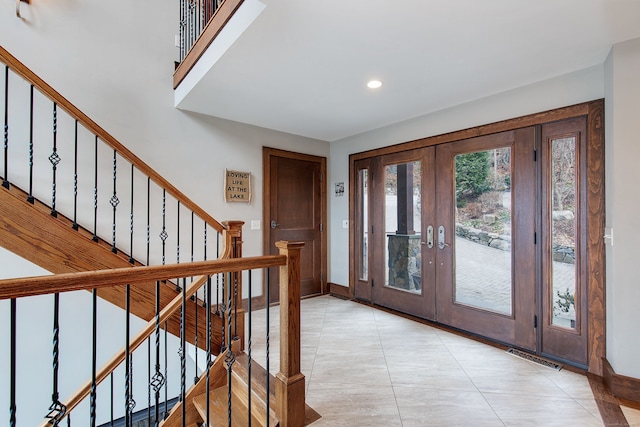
[329,66,604,286]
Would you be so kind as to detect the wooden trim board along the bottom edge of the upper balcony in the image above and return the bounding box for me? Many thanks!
[173,0,244,89]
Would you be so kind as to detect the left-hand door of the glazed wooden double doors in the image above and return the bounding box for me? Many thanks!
[369,147,435,319]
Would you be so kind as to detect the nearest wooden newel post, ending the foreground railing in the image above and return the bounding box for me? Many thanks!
[276,241,305,427]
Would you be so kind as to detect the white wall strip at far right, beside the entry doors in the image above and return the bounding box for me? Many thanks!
[605,39,640,378]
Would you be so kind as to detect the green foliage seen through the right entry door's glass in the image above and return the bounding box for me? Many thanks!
[456,151,491,207]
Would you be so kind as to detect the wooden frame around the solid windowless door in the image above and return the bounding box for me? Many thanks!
[262,146,328,307]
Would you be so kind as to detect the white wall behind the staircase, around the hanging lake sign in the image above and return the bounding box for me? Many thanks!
[0,0,329,295]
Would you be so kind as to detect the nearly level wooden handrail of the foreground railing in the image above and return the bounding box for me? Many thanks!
[0,255,287,300]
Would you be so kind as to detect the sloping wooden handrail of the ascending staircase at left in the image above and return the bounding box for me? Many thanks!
[0,46,224,232]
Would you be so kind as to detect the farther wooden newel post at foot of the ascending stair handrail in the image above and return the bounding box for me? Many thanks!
[222,221,244,349]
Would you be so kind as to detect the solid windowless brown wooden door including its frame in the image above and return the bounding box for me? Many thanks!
[263,148,326,302]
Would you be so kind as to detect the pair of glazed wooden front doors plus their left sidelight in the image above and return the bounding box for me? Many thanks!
[354,127,536,351]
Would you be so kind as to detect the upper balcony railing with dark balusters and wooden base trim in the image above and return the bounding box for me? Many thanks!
[173,0,244,89]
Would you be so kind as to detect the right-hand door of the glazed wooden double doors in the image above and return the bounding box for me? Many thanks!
[435,127,536,351]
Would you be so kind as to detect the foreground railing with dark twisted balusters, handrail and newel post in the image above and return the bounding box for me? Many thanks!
[0,242,305,427]
